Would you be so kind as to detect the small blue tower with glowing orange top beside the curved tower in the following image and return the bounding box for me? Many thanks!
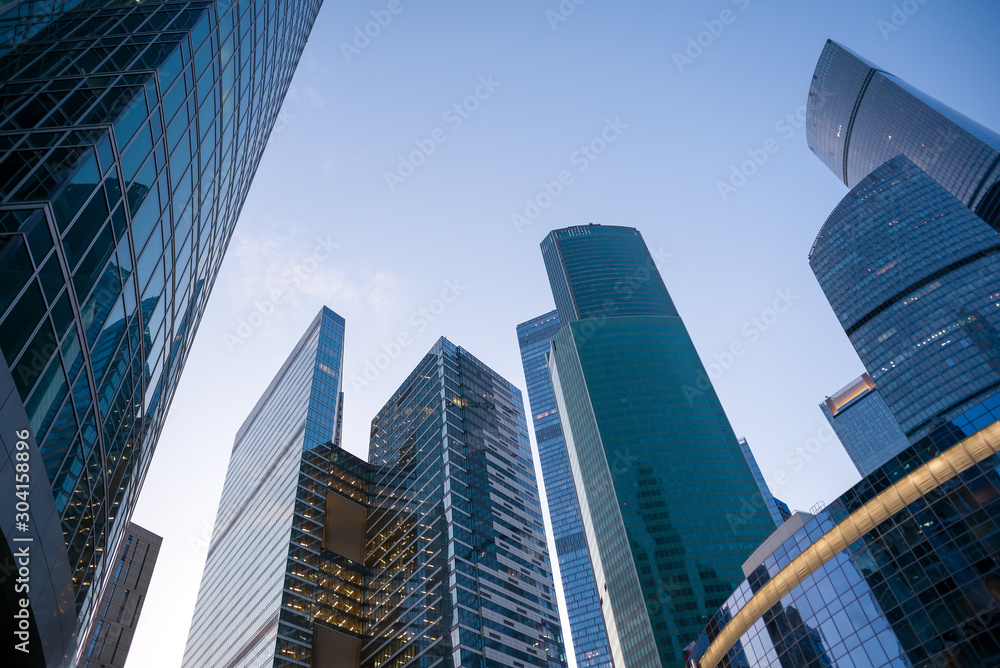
[819,373,910,477]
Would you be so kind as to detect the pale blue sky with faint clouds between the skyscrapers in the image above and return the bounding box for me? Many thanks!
[123,0,1000,668]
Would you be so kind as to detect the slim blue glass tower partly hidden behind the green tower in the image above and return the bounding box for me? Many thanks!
[517,311,611,668]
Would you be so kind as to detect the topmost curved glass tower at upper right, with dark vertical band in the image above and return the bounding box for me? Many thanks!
[806,41,1000,229]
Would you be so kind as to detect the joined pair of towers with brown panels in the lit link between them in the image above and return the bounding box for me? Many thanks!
[183,308,565,668]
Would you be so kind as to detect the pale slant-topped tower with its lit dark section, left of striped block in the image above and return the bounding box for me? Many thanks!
[182,308,366,668]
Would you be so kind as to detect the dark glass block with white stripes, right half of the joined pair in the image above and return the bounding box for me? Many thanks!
[361,338,565,668]
